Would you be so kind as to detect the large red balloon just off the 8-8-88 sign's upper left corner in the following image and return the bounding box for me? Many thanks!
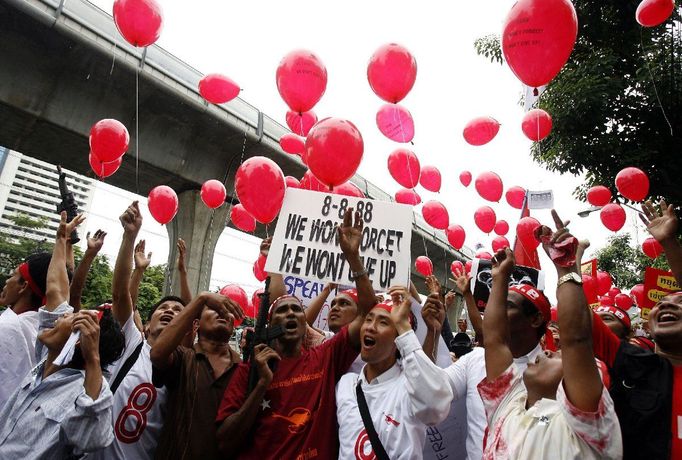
[235,157,284,224]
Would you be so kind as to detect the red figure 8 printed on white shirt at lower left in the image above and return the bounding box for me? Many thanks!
[114,383,156,444]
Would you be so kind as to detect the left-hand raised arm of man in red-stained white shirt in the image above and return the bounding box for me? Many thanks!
[483,248,514,381]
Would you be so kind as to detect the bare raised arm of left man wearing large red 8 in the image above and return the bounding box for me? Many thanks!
[111,201,142,325]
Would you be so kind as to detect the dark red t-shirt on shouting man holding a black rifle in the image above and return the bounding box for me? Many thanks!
[216,327,358,460]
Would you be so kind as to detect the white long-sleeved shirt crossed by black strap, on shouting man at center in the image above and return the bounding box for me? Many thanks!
[336,331,452,460]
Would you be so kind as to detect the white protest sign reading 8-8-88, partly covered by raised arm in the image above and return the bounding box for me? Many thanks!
[265,188,412,290]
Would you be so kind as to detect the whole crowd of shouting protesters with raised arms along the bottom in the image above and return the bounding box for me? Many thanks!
[0,202,682,460]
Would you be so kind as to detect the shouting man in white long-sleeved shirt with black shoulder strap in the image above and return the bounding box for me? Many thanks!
[336,287,452,459]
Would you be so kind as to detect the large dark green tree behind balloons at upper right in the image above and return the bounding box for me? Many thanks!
[474,0,682,204]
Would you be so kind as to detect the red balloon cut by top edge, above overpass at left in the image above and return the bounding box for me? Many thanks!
[114,0,163,48]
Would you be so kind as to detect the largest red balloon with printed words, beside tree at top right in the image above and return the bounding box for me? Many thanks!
[502,0,578,88]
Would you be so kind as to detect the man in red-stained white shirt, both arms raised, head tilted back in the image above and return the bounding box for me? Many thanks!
[478,212,623,459]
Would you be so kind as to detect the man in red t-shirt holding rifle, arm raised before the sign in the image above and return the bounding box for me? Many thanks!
[216,209,375,460]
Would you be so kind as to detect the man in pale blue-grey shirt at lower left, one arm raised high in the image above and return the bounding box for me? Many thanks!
[0,212,124,459]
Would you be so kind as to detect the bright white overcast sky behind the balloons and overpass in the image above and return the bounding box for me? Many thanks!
[79,0,645,298]
